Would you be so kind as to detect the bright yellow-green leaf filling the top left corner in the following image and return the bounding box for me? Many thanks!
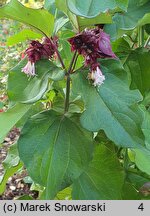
[0,0,54,36]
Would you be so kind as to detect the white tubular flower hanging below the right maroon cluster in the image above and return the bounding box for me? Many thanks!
[89,67,105,87]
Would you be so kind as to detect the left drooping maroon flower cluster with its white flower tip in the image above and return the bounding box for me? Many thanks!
[22,38,58,76]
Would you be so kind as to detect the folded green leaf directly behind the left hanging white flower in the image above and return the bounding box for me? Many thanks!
[7,59,65,103]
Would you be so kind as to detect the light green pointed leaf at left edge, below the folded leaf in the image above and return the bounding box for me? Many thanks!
[0,104,31,142]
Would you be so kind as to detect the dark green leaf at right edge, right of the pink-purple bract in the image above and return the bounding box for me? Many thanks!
[126,49,150,94]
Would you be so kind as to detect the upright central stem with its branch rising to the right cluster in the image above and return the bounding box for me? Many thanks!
[64,51,77,113]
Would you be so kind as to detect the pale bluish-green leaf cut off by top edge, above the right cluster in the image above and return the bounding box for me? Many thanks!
[67,0,128,18]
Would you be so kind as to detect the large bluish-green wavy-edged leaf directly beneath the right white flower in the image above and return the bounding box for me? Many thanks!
[72,60,143,147]
